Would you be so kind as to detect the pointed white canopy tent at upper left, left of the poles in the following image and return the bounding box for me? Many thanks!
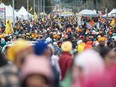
[17,6,33,20]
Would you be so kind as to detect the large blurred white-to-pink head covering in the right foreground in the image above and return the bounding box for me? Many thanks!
[74,50,105,79]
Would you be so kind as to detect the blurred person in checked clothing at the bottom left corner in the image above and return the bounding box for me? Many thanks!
[0,48,20,87]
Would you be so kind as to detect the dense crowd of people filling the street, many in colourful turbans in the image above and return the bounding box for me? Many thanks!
[0,15,116,87]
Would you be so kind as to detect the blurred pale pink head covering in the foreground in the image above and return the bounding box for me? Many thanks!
[21,55,53,80]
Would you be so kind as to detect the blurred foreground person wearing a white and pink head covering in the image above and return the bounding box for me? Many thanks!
[72,49,105,87]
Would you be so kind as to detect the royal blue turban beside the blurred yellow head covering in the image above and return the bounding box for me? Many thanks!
[34,41,48,55]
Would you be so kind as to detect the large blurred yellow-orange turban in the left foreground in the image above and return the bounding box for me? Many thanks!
[7,39,31,61]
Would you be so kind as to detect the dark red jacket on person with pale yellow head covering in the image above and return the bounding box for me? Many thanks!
[59,52,73,80]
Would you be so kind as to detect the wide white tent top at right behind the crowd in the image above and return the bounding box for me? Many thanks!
[79,9,99,17]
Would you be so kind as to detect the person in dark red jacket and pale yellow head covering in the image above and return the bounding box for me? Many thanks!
[59,41,73,80]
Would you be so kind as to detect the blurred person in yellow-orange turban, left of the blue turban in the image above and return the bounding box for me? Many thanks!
[7,39,34,69]
